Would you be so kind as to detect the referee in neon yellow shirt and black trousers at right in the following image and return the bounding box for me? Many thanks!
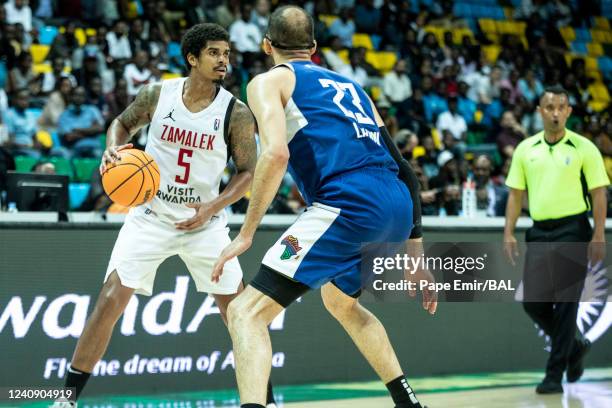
[504,86,609,394]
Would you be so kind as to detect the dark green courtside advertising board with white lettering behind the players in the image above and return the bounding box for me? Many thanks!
[0,223,612,395]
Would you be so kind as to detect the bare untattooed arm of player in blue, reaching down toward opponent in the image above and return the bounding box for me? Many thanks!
[212,69,295,281]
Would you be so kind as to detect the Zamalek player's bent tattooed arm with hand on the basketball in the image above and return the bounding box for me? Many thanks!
[100,83,161,173]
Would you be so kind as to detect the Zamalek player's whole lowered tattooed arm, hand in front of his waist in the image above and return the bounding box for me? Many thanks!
[176,101,257,230]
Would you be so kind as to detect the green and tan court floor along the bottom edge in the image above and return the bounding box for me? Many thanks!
[13,367,612,408]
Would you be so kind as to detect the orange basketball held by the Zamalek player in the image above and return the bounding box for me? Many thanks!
[102,149,159,207]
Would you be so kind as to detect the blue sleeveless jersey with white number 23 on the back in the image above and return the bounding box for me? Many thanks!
[282,61,398,205]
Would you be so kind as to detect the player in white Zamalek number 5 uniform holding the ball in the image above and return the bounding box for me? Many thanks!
[56,24,275,407]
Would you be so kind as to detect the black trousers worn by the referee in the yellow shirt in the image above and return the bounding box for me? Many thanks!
[523,213,592,382]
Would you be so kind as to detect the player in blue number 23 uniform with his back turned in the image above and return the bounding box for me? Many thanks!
[212,6,437,408]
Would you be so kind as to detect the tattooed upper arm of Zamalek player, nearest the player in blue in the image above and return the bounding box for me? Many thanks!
[230,101,257,173]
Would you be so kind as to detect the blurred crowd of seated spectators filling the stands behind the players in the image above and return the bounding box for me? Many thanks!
[0,0,612,216]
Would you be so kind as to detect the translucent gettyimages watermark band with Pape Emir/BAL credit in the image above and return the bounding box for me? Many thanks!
[361,242,608,302]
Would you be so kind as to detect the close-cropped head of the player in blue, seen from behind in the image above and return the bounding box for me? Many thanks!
[266,6,314,51]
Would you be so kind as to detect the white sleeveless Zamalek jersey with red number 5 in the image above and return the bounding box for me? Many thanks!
[141,78,235,225]
